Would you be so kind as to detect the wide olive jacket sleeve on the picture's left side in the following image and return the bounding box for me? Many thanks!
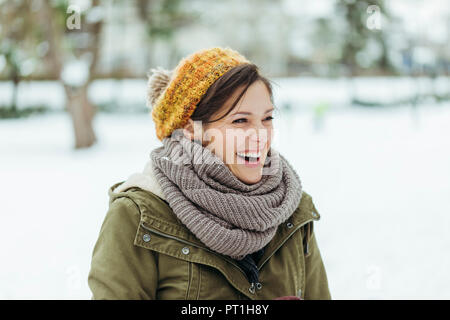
[88,197,158,300]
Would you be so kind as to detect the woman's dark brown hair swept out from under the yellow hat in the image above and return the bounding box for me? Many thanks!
[190,63,275,124]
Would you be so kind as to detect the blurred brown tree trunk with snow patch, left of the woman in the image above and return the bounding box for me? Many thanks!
[39,0,103,148]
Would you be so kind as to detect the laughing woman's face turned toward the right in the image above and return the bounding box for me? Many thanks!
[185,80,273,184]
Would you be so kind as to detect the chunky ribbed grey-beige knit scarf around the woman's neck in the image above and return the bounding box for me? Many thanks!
[150,130,302,260]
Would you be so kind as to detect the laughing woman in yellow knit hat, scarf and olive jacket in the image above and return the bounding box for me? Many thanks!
[88,47,331,299]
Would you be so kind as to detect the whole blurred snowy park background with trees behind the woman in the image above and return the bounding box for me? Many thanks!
[0,0,450,299]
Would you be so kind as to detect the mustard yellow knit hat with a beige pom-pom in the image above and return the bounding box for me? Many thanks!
[147,47,251,141]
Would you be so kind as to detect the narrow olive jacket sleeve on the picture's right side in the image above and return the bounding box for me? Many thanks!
[304,228,331,300]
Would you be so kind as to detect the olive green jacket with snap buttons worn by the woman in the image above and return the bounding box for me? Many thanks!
[88,181,331,300]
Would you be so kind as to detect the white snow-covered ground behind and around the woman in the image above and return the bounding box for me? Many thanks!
[0,104,450,299]
